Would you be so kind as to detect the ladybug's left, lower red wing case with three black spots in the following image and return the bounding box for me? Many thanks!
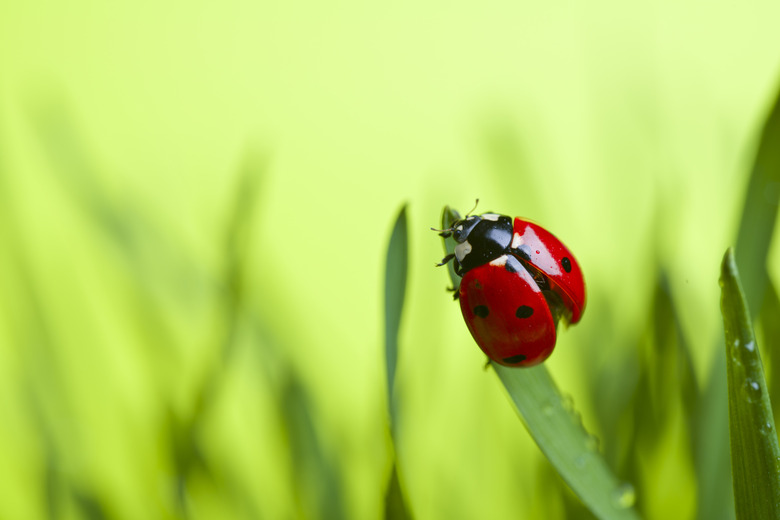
[459,255,555,367]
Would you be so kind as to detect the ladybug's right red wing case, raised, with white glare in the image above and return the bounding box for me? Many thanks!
[510,217,585,325]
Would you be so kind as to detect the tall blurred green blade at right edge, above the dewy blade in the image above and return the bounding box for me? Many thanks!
[736,83,780,313]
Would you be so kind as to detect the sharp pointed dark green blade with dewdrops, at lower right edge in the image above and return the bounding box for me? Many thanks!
[720,249,780,519]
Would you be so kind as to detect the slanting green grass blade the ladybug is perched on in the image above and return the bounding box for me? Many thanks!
[442,207,639,519]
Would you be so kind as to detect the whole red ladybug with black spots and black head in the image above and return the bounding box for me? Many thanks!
[436,209,585,367]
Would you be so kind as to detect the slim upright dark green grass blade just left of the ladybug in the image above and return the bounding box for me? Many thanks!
[385,204,409,424]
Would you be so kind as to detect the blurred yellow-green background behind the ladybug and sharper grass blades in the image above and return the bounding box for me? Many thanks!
[0,0,780,519]
